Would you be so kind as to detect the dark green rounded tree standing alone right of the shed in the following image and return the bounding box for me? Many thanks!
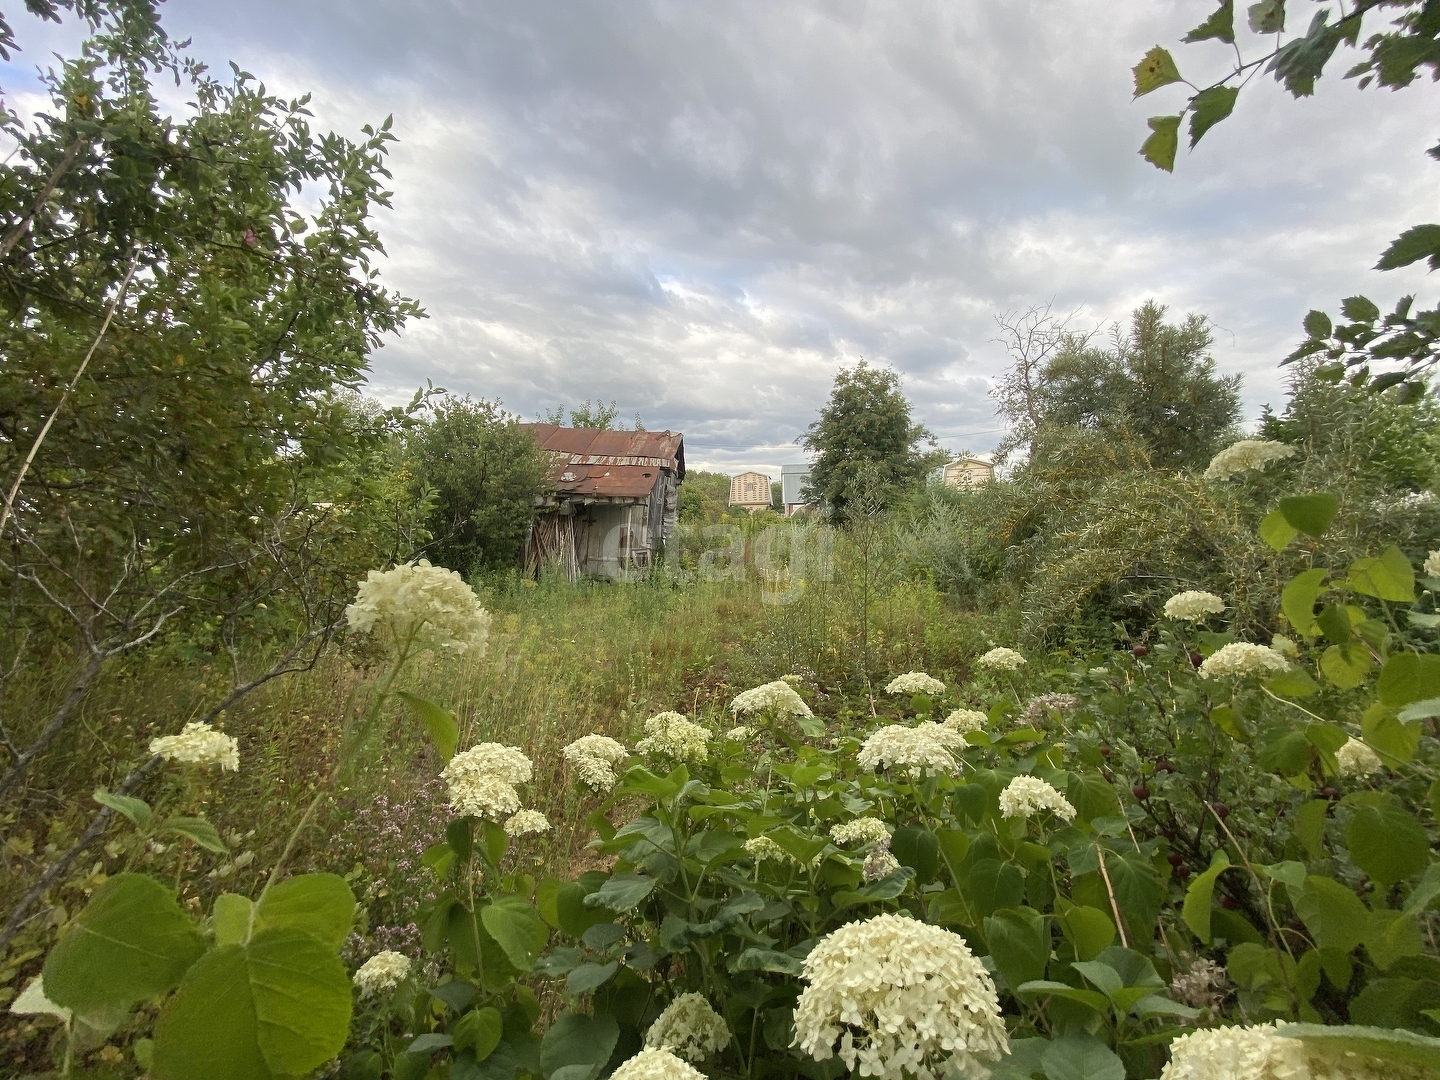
[801,360,945,520]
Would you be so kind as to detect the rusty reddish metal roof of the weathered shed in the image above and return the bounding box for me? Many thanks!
[520,423,685,498]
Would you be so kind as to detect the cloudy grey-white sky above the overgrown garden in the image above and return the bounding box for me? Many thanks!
[0,0,1440,474]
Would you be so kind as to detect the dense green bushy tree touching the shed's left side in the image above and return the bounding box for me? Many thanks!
[406,396,549,575]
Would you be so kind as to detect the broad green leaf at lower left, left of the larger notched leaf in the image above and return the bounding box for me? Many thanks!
[43,874,204,1014]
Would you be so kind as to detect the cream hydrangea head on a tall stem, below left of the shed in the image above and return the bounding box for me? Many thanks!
[346,559,490,654]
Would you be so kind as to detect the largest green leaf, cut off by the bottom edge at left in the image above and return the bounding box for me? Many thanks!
[154,927,351,1080]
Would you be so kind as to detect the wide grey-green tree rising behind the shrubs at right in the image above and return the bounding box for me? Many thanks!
[1001,301,1240,471]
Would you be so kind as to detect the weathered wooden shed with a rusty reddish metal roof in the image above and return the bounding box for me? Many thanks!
[521,423,685,580]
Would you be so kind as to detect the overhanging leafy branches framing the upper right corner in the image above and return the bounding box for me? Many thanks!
[1133,0,1440,399]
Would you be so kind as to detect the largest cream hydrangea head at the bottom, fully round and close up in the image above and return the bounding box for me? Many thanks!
[793,913,1009,1080]
